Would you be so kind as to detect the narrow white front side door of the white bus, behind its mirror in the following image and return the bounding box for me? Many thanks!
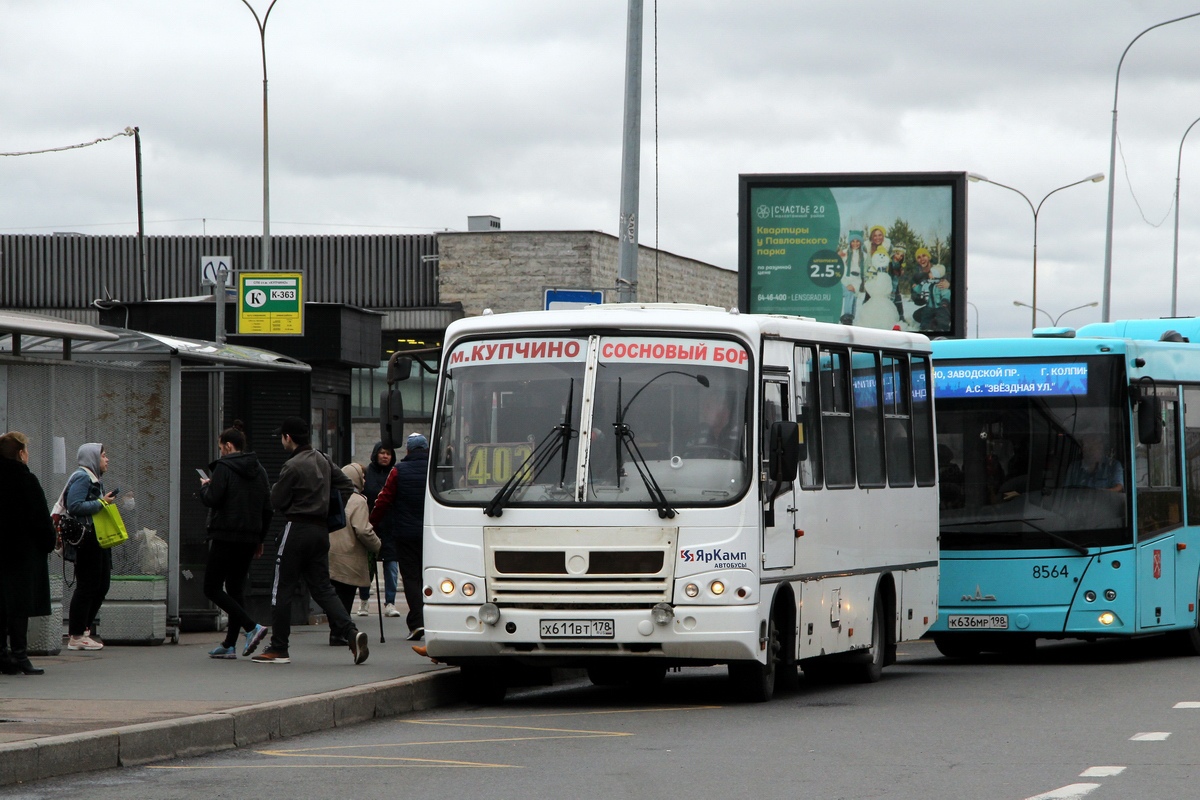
[758,342,796,570]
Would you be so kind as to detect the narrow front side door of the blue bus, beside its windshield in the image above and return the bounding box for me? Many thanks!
[1134,386,1183,628]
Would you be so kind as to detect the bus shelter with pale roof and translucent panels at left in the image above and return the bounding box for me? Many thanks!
[0,312,311,640]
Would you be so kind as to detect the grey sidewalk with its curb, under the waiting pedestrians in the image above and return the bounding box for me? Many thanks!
[0,615,458,786]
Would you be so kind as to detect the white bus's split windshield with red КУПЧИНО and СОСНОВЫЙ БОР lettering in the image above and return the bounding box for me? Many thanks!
[432,336,751,513]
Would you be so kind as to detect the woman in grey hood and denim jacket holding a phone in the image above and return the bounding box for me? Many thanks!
[54,441,118,650]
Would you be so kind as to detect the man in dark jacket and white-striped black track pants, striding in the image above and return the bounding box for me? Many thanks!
[252,416,370,664]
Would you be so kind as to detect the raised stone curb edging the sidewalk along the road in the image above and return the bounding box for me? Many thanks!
[0,669,461,787]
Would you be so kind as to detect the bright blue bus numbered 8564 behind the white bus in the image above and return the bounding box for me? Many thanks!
[930,318,1200,658]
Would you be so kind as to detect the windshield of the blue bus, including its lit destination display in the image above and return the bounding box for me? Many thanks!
[934,356,1133,552]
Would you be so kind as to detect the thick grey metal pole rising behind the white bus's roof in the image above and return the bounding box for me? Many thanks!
[617,0,642,302]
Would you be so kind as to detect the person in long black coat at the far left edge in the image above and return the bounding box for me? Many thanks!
[0,431,61,675]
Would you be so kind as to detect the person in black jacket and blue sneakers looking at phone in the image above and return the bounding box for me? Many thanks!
[199,420,271,658]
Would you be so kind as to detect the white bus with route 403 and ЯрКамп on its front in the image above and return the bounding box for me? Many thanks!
[424,303,938,702]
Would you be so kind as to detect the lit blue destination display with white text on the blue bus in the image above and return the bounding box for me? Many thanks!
[934,362,1087,399]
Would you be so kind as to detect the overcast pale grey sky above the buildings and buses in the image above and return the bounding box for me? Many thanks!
[0,0,1200,336]
